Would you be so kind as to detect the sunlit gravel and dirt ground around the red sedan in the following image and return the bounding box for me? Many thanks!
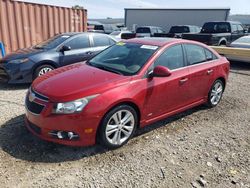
[0,64,250,188]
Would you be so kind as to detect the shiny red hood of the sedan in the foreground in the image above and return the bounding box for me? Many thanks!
[32,63,131,102]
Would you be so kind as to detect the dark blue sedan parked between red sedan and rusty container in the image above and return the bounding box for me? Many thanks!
[0,33,116,84]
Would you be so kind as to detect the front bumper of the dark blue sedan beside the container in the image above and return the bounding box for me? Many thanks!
[0,61,34,84]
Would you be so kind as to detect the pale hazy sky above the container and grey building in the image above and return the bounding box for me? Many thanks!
[19,0,250,18]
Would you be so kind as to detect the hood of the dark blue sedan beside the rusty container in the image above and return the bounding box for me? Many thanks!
[2,48,45,62]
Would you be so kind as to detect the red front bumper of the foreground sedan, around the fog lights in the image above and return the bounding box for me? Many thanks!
[25,90,100,146]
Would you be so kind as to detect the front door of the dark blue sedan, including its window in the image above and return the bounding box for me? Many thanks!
[60,35,90,66]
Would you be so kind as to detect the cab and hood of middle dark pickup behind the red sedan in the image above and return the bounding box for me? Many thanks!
[166,25,201,38]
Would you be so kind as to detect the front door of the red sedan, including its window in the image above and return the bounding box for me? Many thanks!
[144,45,189,119]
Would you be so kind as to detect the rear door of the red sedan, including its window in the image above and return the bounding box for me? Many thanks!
[184,44,217,103]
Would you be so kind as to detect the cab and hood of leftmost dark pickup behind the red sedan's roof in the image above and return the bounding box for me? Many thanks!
[136,26,164,37]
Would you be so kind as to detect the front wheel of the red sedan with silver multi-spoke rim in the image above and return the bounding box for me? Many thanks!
[97,105,138,149]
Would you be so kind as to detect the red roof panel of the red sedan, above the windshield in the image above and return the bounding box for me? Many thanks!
[125,37,185,46]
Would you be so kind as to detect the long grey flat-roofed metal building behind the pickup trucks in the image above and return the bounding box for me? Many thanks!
[125,8,230,32]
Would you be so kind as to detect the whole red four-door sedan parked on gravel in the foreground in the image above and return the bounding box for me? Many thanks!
[25,38,229,148]
